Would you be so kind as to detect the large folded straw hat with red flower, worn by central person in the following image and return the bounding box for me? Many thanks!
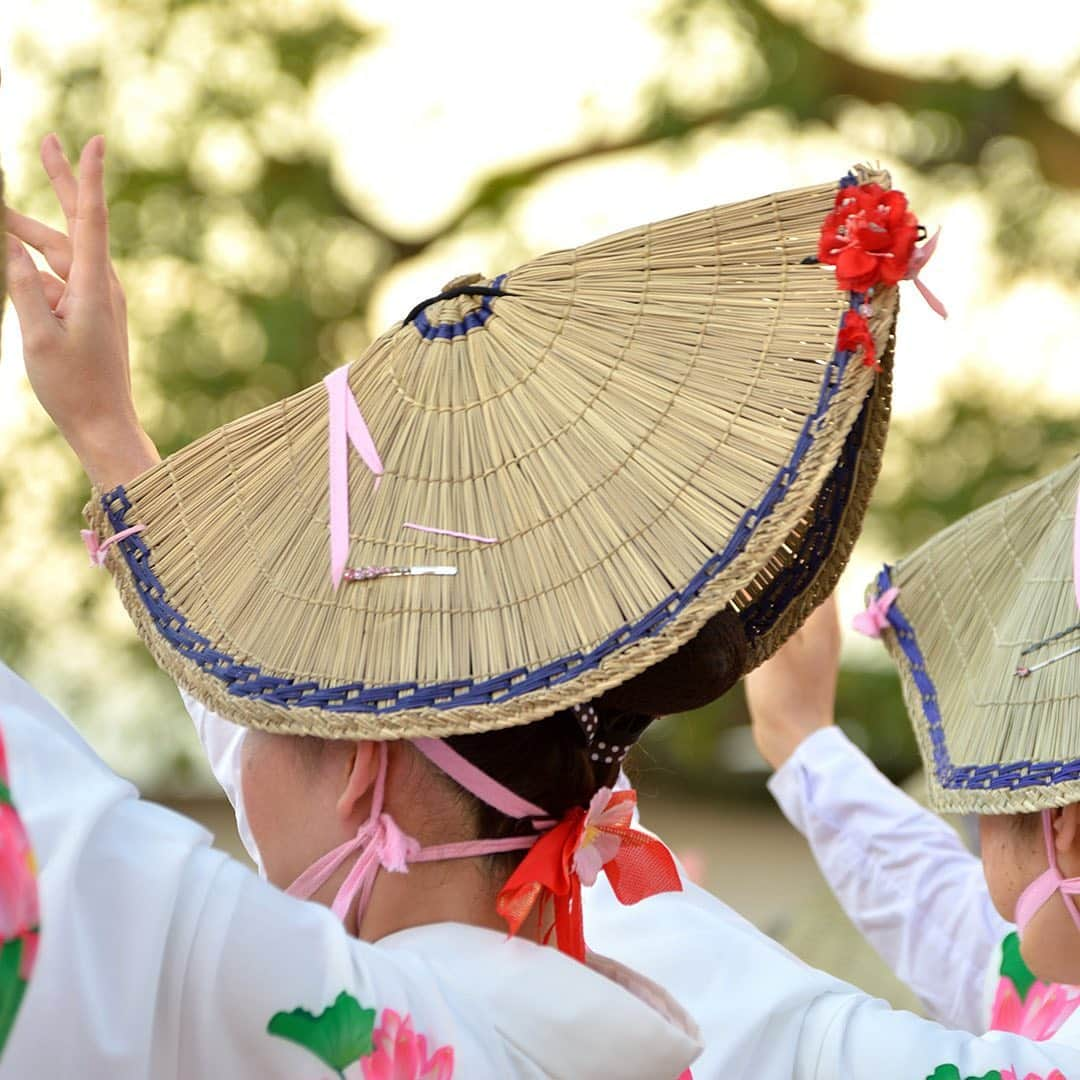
[89,171,915,739]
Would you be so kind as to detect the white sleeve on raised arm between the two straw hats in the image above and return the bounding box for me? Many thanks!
[769,727,1012,1031]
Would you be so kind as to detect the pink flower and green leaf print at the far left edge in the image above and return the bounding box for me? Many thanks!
[0,721,39,1050]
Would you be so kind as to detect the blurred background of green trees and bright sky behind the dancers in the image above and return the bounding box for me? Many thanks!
[0,0,1080,1006]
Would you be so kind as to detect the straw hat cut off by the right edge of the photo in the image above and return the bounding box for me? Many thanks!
[872,457,1080,813]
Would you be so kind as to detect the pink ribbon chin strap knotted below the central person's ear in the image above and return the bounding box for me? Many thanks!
[285,739,551,926]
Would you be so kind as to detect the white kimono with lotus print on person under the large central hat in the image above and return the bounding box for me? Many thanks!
[0,665,699,1080]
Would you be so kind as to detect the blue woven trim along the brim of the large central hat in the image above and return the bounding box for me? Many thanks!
[102,278,863,714]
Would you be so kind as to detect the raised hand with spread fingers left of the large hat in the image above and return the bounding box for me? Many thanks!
[5,135,159,488]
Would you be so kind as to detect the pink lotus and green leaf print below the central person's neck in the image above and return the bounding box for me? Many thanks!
[267,991,454,1080]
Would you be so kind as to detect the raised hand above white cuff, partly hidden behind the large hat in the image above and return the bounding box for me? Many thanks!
[746,596,840,769]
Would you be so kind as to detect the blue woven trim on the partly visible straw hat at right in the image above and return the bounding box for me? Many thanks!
[877,566,1080,791]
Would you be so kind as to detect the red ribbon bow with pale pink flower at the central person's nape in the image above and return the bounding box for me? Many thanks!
[496,787,683,960]
